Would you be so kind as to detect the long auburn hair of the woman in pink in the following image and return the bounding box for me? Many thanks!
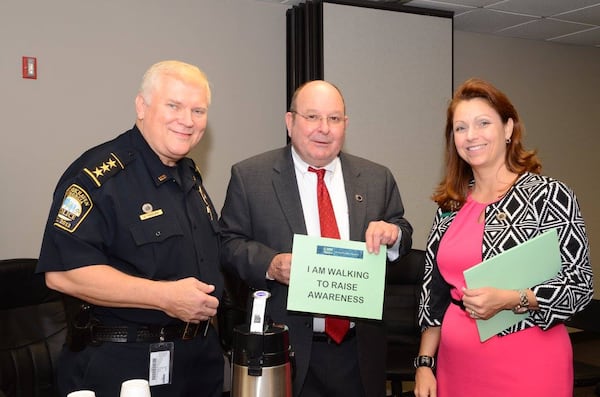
[431,78,542,211]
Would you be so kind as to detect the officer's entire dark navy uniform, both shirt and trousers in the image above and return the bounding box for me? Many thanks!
[38,127,223,397]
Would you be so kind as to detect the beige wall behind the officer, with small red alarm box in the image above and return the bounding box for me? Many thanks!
[0,0,288,258]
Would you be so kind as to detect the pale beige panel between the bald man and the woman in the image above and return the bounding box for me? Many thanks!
[323,3,452,249]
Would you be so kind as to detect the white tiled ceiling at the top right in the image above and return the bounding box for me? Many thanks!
[261,0,600,49]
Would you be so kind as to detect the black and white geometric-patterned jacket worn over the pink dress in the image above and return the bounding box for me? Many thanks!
[419,173,593,335]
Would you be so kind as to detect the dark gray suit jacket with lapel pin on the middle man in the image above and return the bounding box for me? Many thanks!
[221,145,412,397]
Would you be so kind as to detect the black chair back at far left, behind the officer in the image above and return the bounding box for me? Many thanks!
[0,258,67,397]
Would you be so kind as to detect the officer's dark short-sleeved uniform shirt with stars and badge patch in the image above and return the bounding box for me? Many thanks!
[37,127,223,325]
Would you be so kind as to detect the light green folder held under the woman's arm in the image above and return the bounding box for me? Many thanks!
[463,229,561,342]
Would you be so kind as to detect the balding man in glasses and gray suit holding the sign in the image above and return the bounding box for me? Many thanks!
[221,81,412,397]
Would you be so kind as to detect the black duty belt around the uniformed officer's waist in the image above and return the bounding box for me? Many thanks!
[90,321,210,344]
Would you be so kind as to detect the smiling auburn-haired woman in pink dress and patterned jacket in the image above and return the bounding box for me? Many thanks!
[415,79,593,397]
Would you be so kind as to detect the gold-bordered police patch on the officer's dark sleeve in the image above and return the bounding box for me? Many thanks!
[54,184,94,233]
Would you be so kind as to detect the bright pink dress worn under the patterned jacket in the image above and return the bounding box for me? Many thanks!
[436,197,573,397]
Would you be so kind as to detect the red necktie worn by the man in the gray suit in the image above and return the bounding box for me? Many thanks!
[308,167,350,344]
